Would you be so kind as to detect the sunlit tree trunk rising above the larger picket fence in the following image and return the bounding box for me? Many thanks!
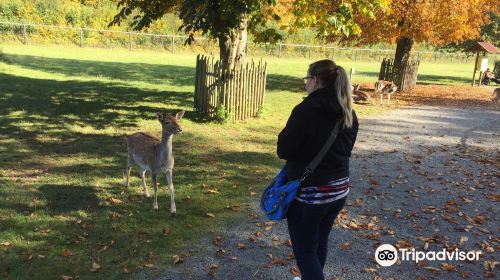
[218,16,247,70]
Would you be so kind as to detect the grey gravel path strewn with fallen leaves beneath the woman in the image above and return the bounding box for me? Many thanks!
[158,106,500,280]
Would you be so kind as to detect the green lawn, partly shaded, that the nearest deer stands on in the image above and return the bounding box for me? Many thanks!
[0,42,468,279]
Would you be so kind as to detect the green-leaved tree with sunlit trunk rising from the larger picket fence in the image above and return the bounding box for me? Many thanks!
[110,0,276,68]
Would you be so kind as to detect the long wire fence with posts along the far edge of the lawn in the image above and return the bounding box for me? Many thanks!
[0,22,500,63]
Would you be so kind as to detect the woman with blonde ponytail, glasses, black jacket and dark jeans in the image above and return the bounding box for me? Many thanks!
[277,60,358,280]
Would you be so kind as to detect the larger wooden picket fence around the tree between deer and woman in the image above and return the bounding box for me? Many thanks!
[194,55,267,120]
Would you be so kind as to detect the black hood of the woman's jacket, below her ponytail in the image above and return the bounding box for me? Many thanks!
[304,86,343,119]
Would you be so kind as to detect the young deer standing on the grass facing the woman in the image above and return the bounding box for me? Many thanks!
[125,110,185,215]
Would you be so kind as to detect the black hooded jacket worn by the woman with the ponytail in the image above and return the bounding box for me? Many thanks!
[277,87,359,186]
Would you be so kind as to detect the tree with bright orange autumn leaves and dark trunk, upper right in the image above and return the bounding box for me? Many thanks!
[352,0,500,65]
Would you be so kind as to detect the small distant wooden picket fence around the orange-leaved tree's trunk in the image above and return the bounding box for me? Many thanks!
[378,58,420,91]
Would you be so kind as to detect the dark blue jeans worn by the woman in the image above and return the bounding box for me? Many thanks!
[287,197,346,280]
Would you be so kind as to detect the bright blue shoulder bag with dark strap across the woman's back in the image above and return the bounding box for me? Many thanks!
[260,123,340,221]
